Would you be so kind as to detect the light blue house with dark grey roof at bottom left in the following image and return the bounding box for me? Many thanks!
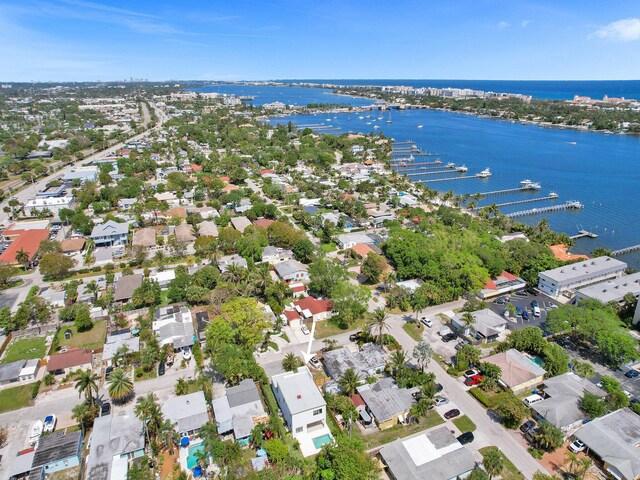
[29,430,82,480]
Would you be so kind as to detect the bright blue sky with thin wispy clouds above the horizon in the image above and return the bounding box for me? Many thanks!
[0,0,640,81]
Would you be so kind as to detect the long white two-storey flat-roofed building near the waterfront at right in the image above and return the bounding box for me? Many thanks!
[538,256,627,298]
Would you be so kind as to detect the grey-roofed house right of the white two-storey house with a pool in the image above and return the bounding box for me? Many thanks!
[358,378,416,430]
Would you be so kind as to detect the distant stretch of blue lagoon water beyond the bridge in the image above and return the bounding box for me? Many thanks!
[192,84,372,106]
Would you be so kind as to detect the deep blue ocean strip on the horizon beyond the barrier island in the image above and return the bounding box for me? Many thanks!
[274,79,640,100]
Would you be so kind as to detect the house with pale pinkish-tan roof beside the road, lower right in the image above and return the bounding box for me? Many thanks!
[483,348,547,395]
